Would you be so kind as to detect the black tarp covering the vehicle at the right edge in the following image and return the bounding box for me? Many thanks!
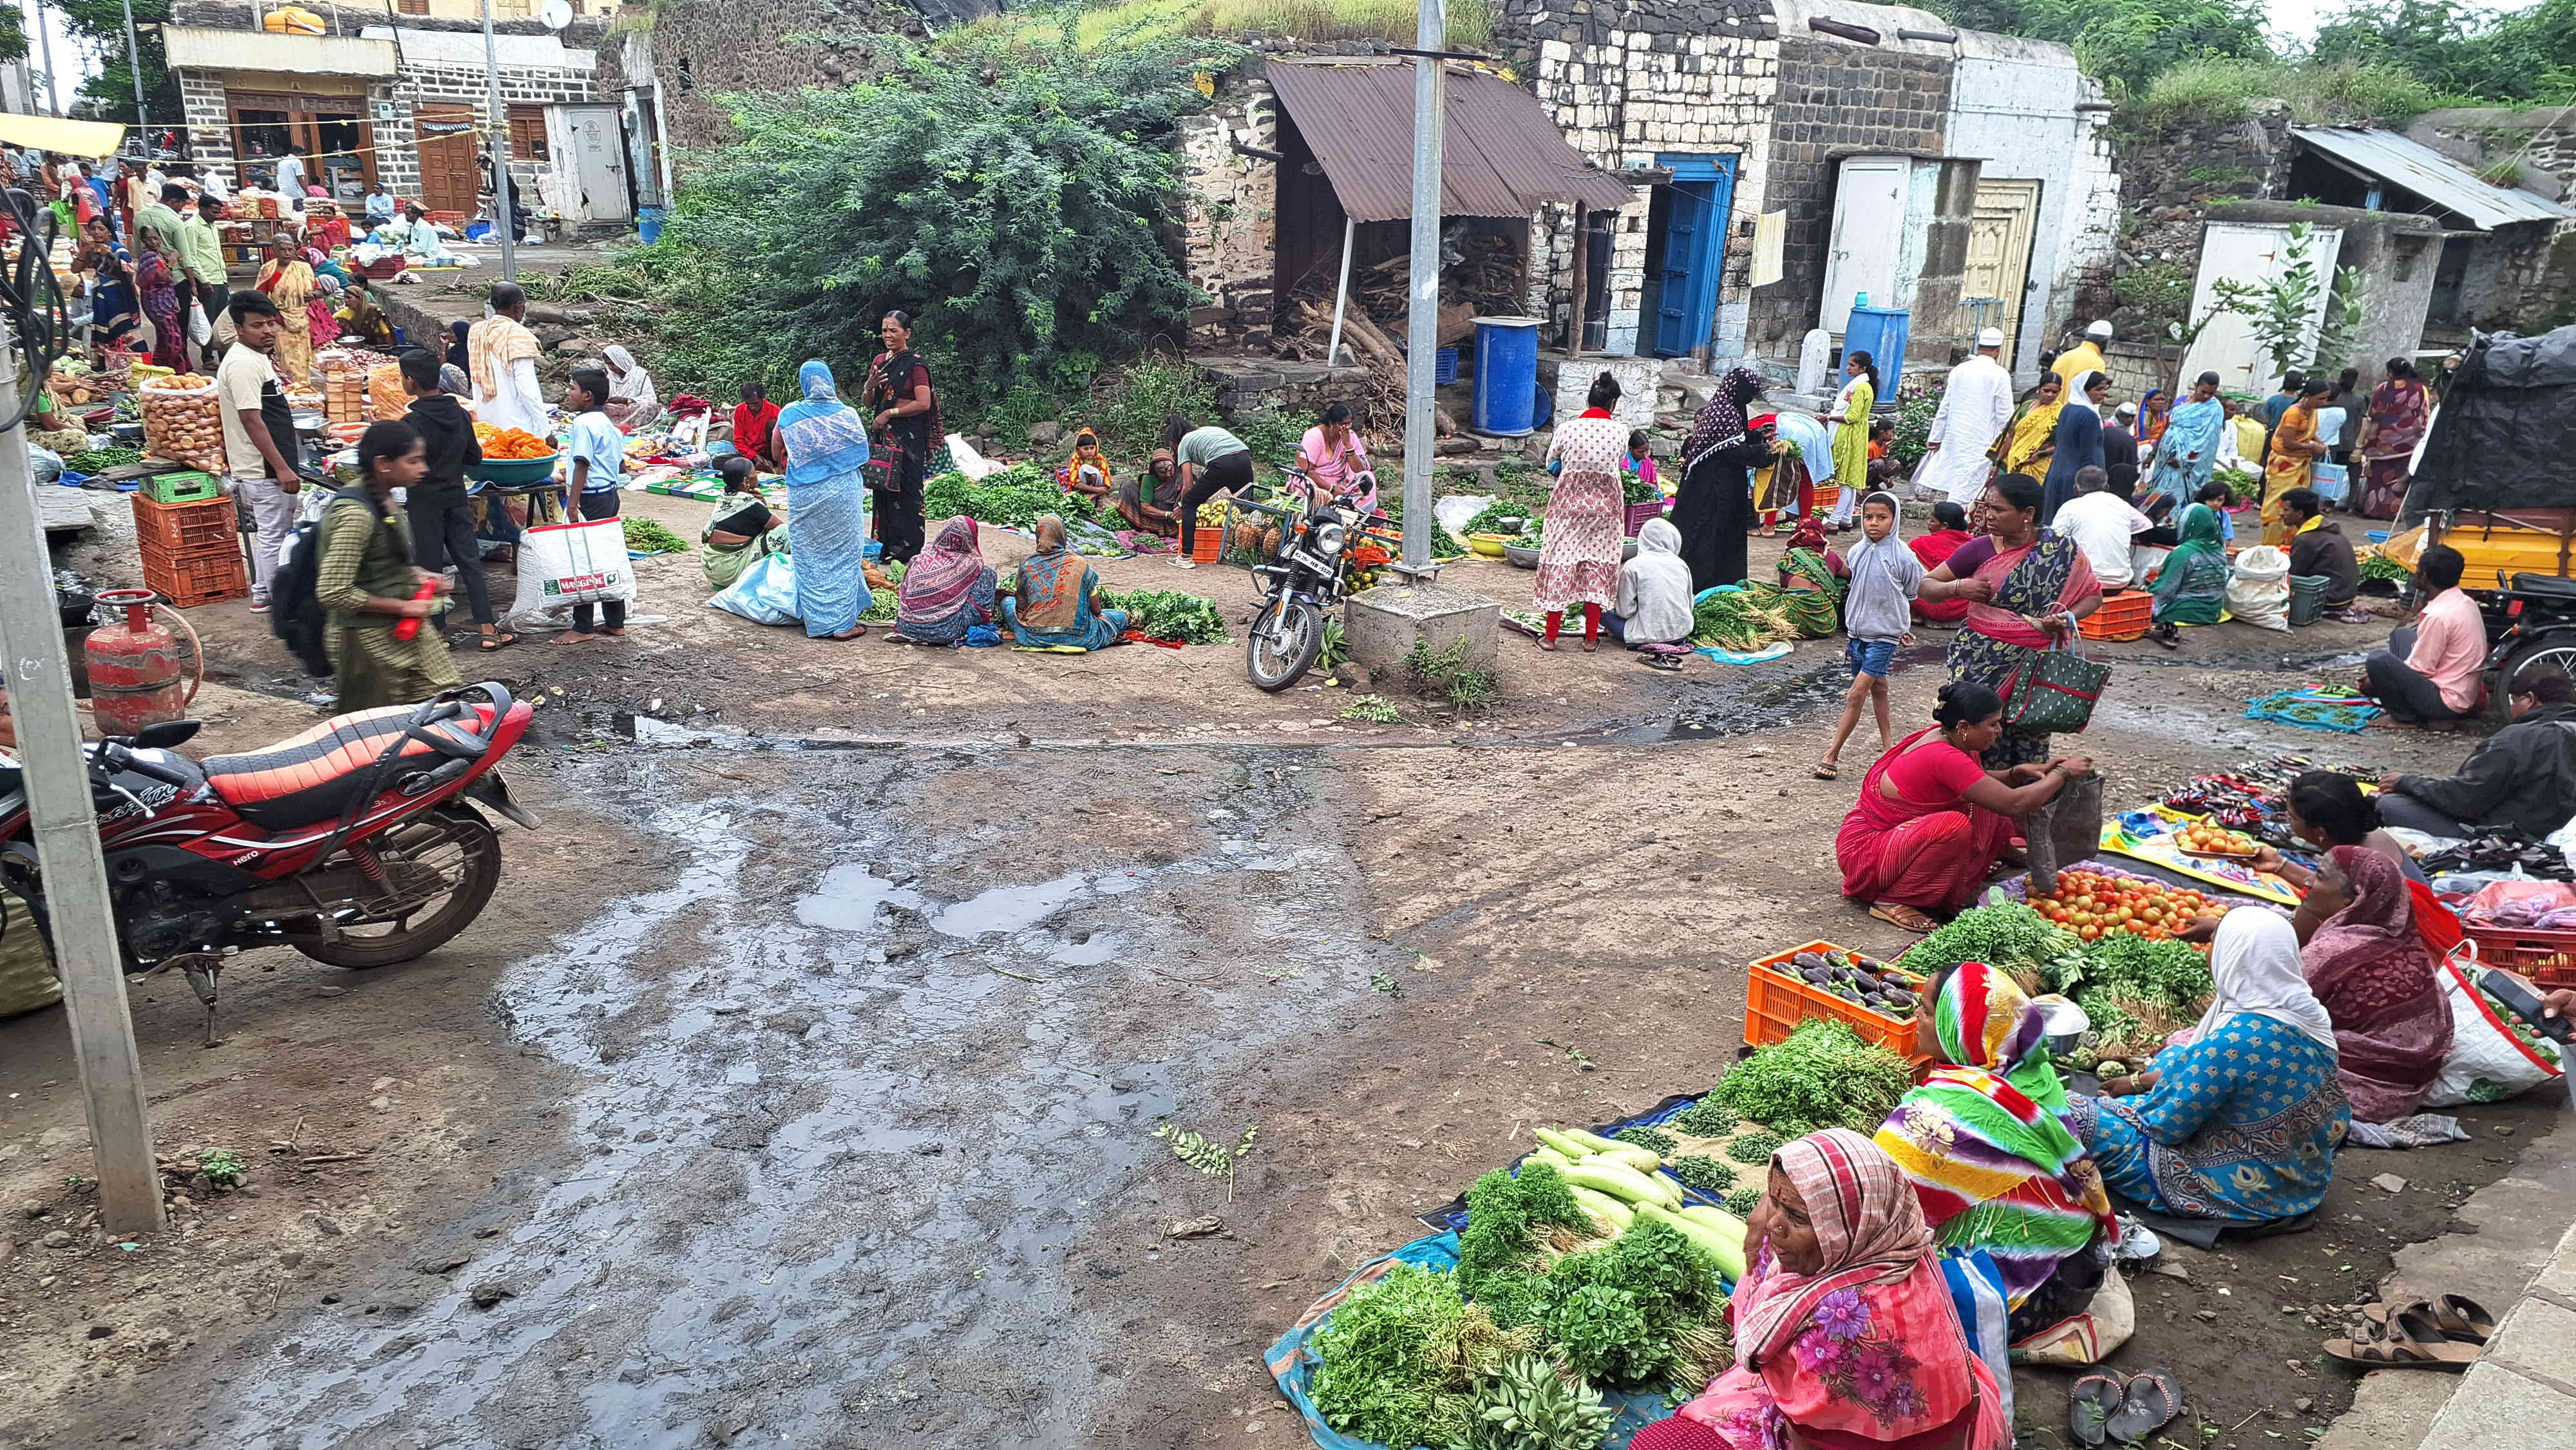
[2398,327,2576,528]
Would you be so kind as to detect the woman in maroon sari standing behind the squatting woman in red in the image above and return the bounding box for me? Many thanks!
[1922,474,2102,770]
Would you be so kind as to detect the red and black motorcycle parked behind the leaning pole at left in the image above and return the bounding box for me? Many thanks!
[0,683,536,1046]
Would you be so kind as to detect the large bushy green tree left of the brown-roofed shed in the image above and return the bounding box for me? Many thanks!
[629,15,1236,415]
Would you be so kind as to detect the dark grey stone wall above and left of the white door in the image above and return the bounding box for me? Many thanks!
[1749,33,1953,358]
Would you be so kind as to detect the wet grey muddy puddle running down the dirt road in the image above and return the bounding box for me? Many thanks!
[219,760,1391,1450]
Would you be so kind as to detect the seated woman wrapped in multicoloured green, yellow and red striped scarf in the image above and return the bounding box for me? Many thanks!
[1878,961,2117,1324]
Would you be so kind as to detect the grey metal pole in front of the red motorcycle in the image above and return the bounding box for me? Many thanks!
[0,327,162,1239]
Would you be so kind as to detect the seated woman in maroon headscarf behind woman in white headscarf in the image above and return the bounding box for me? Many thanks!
[2290,845,2452,1123]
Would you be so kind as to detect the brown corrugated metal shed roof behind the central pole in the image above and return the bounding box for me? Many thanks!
[1270,59,1636,221]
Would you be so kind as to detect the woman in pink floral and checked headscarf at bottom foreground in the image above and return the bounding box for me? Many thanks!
[1633,1128,2012,1450]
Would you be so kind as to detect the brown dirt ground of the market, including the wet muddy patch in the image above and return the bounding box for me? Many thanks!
[0,494,2553,1450]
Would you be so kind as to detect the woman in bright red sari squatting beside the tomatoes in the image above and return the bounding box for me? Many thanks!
[1834,680,2092,932]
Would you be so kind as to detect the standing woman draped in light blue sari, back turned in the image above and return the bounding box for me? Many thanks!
[778,358,871,639]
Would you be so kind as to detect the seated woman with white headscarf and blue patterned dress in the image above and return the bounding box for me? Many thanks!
[2066,907,2352,1223]
